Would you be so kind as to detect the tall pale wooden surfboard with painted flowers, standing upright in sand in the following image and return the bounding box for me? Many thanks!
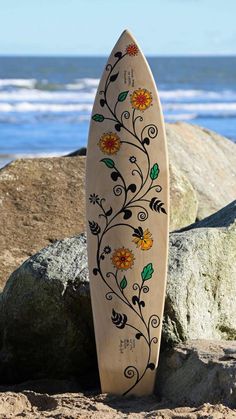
[86,31,169,395]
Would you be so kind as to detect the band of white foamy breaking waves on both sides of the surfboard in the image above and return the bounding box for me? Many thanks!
[0,78,236,123]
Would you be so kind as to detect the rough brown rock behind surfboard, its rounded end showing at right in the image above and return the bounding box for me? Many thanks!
[0,150,197,289]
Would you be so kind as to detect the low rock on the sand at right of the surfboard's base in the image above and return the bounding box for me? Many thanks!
[157,340,236,406]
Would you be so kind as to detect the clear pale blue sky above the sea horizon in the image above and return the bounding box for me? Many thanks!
[0,0,236,55]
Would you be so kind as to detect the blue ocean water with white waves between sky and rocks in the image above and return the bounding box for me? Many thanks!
[0,57,236,165]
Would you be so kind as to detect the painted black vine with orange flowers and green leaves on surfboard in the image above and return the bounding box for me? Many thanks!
[89,43,166,395]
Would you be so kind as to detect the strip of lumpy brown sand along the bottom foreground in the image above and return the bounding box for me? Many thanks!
[0,390,236,419]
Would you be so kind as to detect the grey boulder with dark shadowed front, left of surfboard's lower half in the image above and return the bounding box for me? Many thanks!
[0,235,96,383]
